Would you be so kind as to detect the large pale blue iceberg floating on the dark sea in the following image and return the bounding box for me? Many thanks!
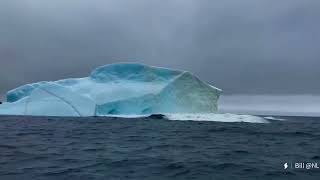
[0,63,221,116]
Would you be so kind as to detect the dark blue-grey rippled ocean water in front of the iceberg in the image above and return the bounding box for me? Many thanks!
[0,116,320,180]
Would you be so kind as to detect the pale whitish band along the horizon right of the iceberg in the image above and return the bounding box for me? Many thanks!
[219,95,320,117]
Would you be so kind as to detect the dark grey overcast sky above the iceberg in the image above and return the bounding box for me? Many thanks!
[0,0,320,100]
